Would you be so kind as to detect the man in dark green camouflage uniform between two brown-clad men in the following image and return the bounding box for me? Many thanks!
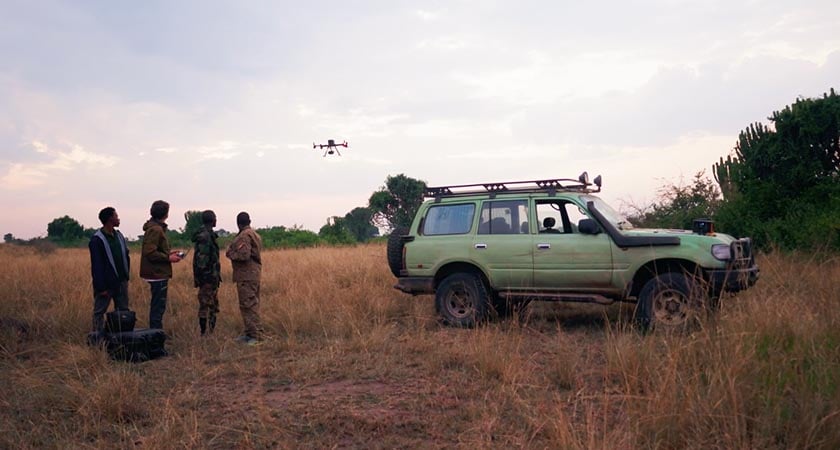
[192,210,222,336]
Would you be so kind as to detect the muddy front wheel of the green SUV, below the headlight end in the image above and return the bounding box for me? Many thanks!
[635,272,707,331]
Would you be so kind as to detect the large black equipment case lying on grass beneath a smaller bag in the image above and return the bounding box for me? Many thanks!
[88,328,168,362]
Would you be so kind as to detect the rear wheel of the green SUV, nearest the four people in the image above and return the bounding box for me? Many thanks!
[435,273,490,328]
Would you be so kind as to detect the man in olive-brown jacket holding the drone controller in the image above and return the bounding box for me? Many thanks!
[140,200,181,329]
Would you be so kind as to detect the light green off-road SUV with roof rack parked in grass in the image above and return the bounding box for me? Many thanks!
[388,172,759,328]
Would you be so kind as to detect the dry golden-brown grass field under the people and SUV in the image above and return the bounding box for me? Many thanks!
[0,245,840,449]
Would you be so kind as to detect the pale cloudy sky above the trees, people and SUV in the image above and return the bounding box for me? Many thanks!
[0,0,840,238]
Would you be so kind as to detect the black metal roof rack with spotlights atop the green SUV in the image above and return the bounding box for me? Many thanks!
[425,172,601,199]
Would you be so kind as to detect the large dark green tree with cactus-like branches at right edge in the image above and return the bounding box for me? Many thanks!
[713,89,840,248]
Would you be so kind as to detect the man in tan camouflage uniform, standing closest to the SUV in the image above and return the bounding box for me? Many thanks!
[225,212,263,345]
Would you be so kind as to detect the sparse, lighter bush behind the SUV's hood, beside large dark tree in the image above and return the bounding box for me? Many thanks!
[627,171,721,230]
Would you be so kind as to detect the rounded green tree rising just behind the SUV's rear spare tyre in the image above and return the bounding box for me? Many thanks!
[368,174,426,229]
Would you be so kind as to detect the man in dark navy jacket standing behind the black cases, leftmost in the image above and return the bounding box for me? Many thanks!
[88,206,131,332]
